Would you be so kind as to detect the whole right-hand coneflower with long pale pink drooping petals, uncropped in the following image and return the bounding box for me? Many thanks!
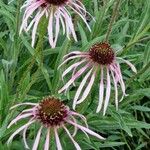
[59,42,136,115]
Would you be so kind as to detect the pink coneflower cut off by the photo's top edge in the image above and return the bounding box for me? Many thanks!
[20,0,91,48]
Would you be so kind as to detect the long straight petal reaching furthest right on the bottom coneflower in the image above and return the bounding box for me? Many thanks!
[67,120,105,140]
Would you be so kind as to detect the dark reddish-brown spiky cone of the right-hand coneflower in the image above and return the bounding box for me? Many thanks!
[89,42,115,65]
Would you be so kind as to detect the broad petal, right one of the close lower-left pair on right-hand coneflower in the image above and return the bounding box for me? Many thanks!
[76,70,96,104]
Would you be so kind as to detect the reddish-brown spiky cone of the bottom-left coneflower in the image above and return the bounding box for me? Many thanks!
[37,97,68,126]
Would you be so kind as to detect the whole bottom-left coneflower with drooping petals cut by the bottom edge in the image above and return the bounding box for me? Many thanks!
[8,97,104,150]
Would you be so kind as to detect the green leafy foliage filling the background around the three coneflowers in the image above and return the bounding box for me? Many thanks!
[0,0,150,150]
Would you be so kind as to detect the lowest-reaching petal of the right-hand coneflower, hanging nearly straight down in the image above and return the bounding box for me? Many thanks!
[103,68,111,116]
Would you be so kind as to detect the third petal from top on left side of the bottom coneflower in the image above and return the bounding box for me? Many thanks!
[7,120,35,145]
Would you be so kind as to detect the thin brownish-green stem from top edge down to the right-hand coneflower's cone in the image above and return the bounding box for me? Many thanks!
[105,0,120,42]
